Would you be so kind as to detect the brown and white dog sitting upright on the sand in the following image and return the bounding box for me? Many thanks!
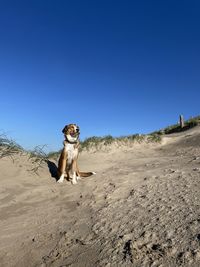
[58,124,96,184]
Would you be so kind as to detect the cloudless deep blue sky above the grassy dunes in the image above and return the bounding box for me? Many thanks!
[0,0,200,150]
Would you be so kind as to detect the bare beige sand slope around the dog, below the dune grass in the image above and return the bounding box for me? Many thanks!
[0,127,200,267]
